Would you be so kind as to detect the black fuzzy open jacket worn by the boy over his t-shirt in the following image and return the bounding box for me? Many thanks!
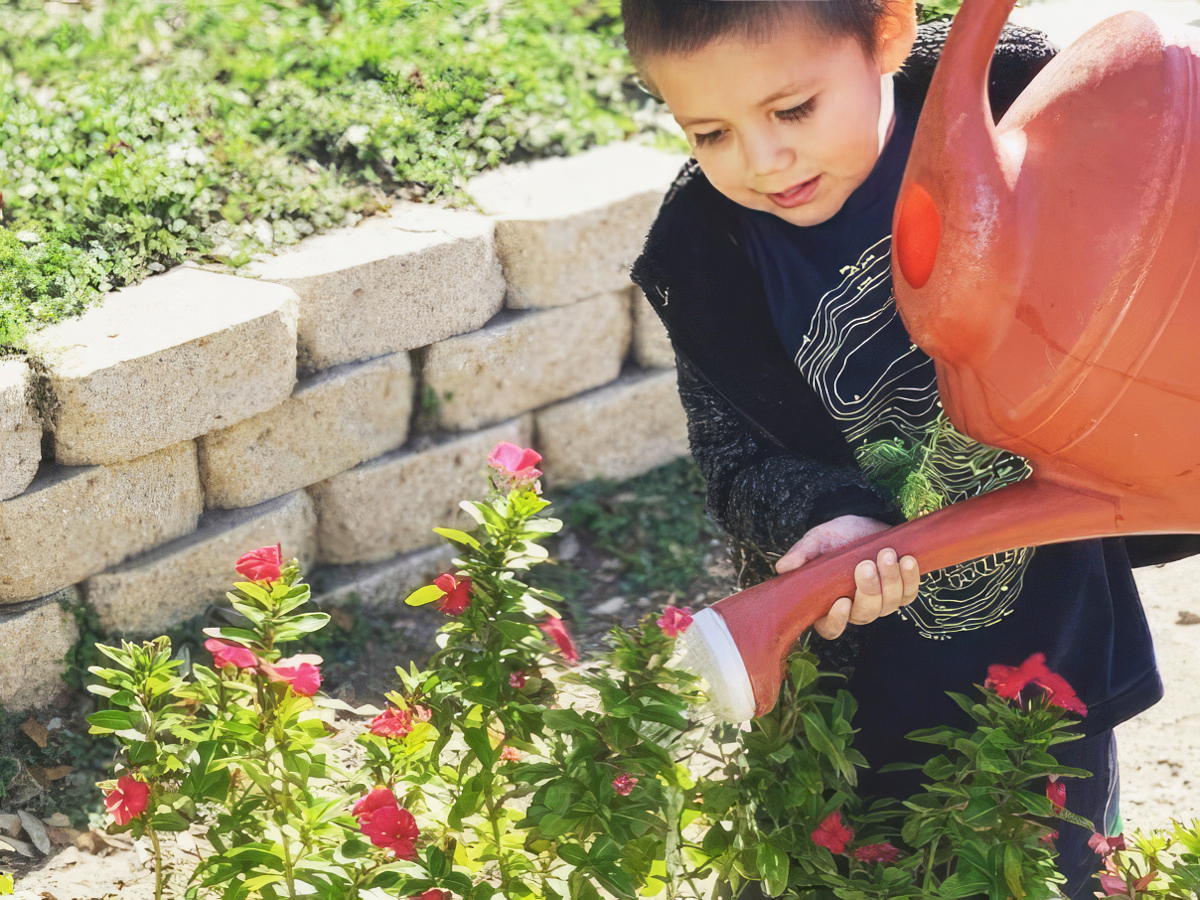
[632,22,1200,587]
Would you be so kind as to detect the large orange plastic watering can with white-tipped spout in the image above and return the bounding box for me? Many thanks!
[684,0,1200,721]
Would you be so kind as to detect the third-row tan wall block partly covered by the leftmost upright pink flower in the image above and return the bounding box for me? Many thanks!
[84,491,317,637]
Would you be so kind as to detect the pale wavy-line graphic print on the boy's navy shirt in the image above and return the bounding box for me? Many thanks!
[796,236,1033,640]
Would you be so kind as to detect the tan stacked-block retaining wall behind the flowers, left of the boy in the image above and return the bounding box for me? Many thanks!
[0,144,686,708]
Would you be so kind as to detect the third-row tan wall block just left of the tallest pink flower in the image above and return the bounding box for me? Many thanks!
[308,416,533,563]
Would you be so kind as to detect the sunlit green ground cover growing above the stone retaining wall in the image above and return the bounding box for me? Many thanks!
[0,0,684,353]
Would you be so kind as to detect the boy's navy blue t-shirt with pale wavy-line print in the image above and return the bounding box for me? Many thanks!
[740,93,1162,794]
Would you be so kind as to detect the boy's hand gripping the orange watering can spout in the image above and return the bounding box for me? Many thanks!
[775,516,920,640]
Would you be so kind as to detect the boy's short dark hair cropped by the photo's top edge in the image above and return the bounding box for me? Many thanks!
[620,0,888,90]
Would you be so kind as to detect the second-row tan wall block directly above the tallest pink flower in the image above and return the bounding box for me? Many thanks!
[422,292,632,431]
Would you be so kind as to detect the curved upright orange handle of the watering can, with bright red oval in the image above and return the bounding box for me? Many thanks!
[893,0,1020,366]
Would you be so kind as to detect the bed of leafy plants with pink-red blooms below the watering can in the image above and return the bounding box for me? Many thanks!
[90,445,1200,900]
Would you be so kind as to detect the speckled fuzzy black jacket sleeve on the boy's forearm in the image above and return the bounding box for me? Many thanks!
[676,353,900,560]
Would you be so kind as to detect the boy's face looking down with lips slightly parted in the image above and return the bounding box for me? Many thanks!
[644,20,911,226]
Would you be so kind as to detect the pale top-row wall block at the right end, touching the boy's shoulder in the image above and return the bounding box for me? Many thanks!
[467,143,686,308]
